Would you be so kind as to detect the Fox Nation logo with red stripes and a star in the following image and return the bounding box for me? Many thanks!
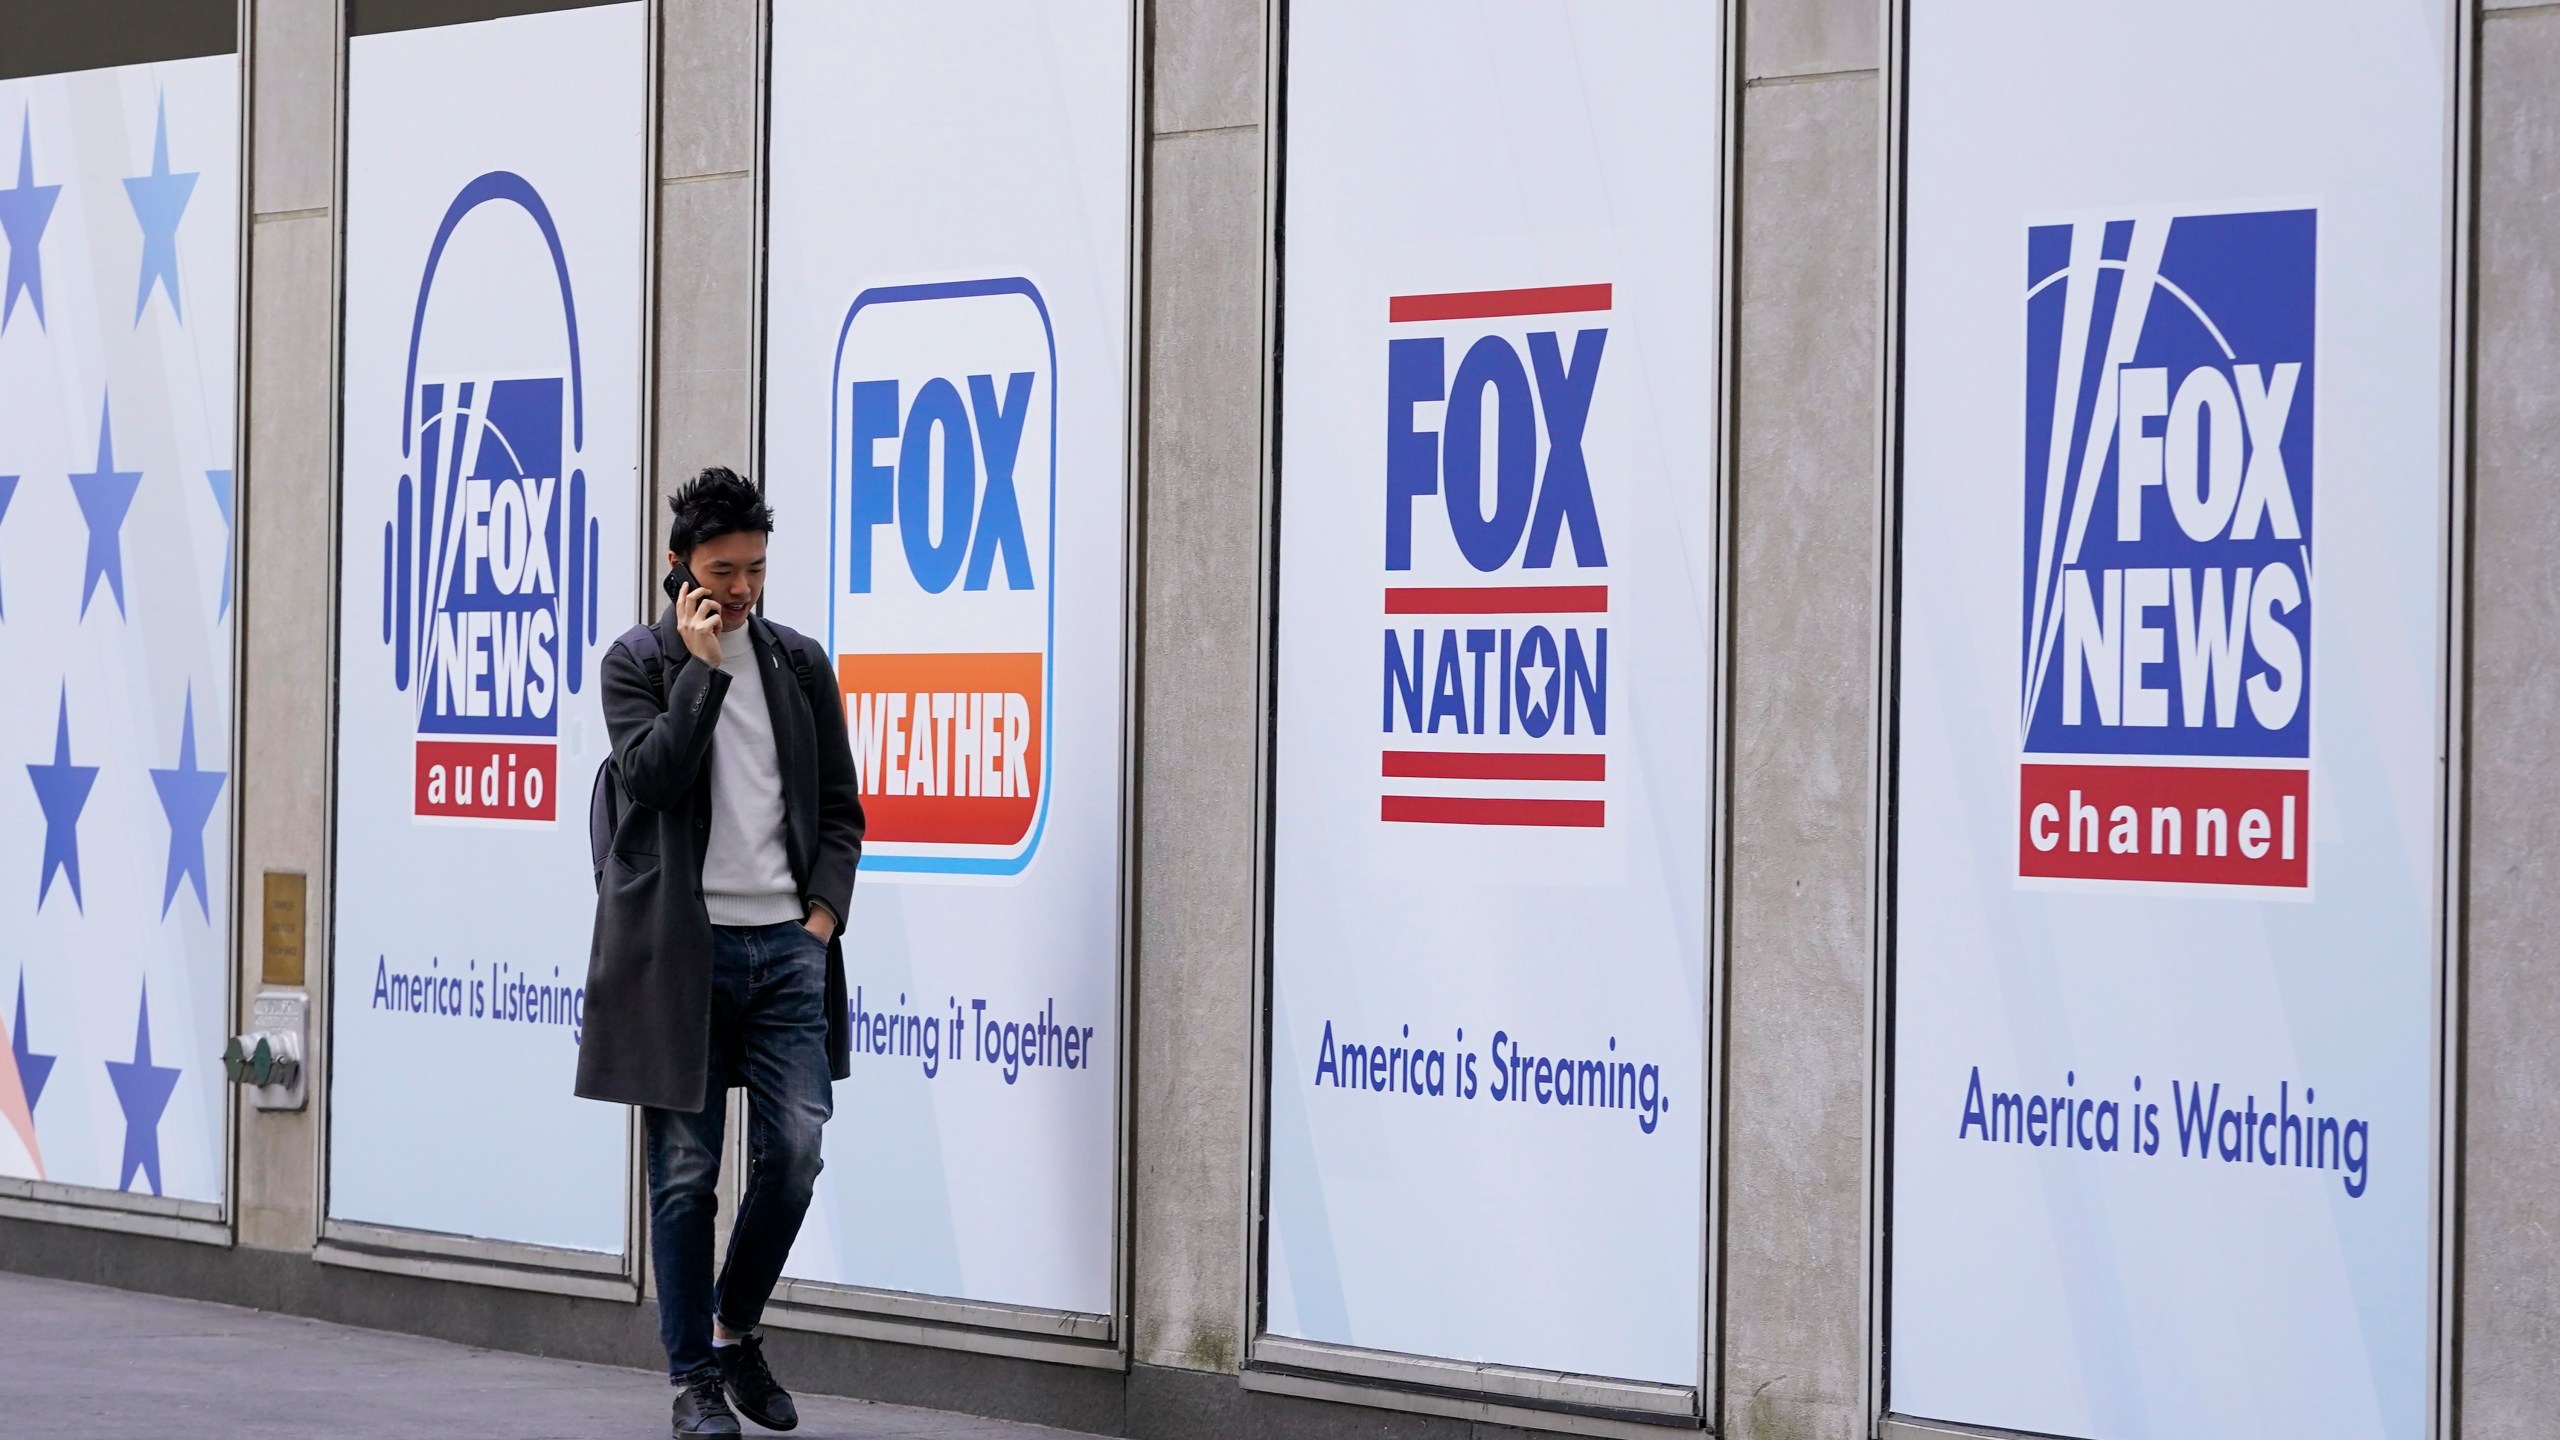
[1377,284,1613,828]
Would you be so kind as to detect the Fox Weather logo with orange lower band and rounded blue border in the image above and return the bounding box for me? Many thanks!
[829,277,1057,876]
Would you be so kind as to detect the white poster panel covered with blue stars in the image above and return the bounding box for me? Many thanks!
[0,54,241,1204]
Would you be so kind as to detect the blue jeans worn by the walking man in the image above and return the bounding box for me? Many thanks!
[640,920,835,1384]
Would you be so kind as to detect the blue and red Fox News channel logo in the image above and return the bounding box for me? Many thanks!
[2017,210,2319,892]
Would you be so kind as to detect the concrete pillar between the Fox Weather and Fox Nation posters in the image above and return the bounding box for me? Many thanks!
[1134,0,1265,1371]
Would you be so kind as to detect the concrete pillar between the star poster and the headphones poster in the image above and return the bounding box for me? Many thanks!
[230,0,340,1250]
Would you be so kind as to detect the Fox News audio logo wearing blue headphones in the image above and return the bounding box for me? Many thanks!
[381,172,599,825]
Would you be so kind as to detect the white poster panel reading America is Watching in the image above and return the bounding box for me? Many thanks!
[1889,0,2455,1440]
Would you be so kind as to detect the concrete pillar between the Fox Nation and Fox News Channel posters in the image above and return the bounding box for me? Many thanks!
[1720,0,1884,1440]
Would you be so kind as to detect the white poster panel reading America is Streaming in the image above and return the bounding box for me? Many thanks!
[1265,0,1723,1386]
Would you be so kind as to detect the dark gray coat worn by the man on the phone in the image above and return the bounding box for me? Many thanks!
[579,605,863,1109]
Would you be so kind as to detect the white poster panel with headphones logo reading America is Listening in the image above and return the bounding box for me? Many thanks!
[328,5,648,1253]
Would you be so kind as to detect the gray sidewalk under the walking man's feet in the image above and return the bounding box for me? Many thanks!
[0,1273,1090,1440]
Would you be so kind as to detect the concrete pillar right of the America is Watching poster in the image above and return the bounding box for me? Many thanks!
[2458,5,2560,1440]
